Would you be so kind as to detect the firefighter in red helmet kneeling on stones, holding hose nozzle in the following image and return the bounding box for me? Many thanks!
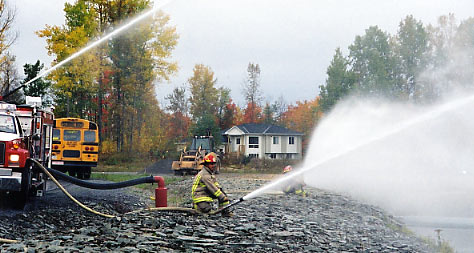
[191,152,232,217]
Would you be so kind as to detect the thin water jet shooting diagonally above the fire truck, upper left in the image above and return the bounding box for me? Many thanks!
[3,0,171,97]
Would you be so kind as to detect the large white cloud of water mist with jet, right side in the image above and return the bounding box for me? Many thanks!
[244,93,474,217]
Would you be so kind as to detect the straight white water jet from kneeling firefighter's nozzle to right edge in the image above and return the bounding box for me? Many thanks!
[237,95,474,205]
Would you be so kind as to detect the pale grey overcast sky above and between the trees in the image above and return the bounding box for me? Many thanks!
[7,0,474,106]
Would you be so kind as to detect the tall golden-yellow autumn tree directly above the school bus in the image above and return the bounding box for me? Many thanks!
[37,1,100,119]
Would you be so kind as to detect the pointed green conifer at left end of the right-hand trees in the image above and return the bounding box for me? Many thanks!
[319,48,355,112]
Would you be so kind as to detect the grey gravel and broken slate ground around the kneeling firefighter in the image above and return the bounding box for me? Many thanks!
[0,173,434,252]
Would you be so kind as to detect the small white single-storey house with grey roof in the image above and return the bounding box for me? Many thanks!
[222,124,303,159]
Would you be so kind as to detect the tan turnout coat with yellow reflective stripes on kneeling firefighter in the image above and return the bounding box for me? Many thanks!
[191,166,230,208]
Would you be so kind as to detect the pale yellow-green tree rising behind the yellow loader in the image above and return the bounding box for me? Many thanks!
[188,64,218,120]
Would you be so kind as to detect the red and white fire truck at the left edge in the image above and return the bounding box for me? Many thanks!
[0,98,54,208]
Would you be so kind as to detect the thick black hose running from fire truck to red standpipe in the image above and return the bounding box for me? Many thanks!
[48,168,156,190]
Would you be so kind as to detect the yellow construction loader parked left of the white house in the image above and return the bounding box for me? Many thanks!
[171,135,221,175]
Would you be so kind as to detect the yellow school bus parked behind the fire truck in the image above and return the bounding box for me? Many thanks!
[51,118,99,179]
